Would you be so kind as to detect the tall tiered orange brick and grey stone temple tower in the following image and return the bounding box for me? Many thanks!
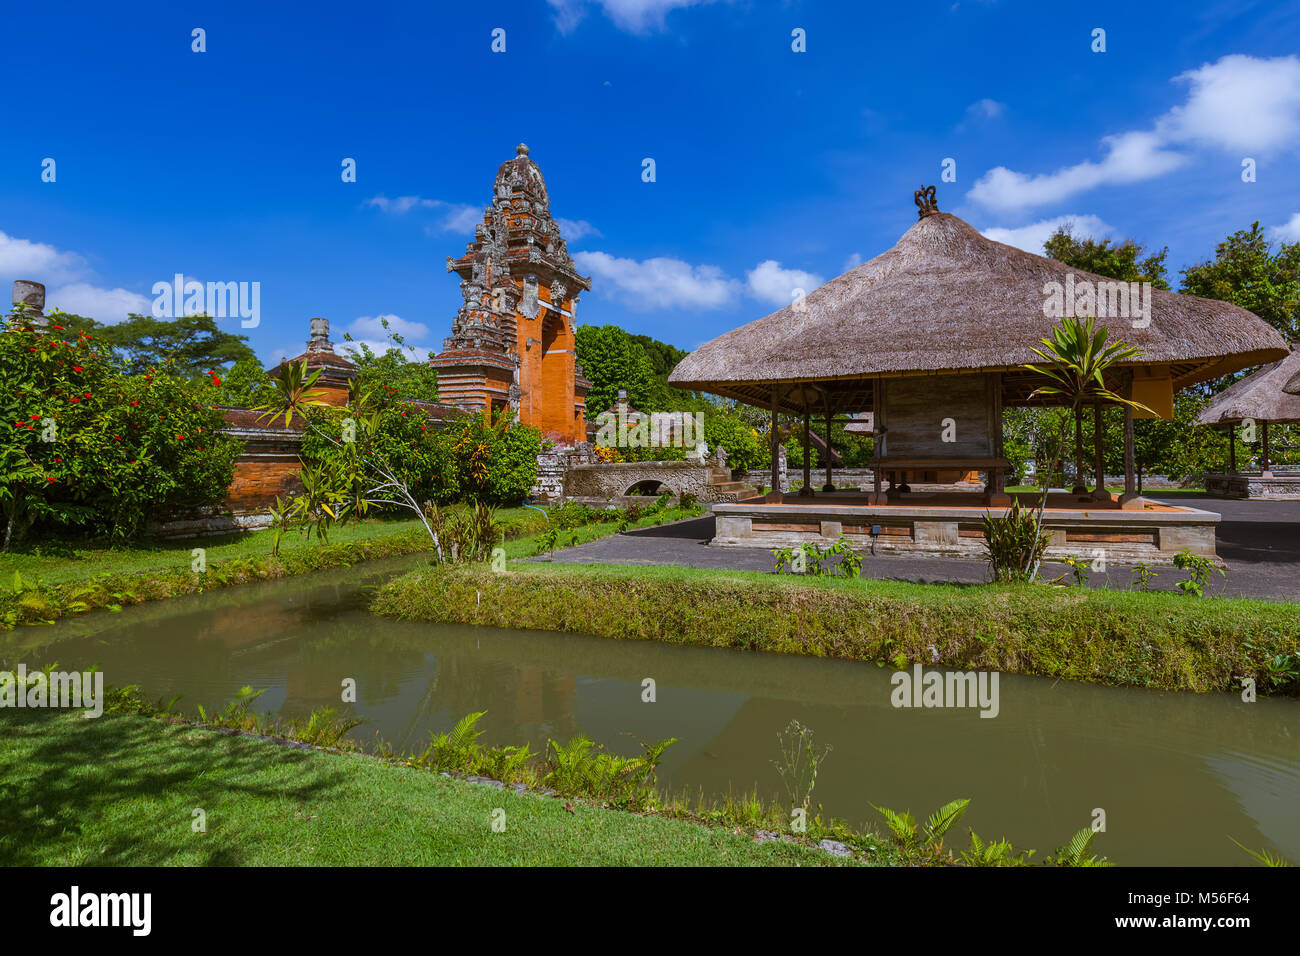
[430,143,592,444]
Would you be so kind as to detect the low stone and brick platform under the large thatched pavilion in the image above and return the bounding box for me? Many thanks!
[710,492,1219,564]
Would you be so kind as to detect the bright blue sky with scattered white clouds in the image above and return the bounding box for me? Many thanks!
[0,0,1300,362]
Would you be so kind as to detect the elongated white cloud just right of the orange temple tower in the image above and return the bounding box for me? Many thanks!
[573,252,740,310]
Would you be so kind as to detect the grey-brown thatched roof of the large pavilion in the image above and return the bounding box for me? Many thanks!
[668,212,1287,411]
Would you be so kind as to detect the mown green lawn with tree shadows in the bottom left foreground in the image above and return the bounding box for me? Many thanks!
[0,710,844,866]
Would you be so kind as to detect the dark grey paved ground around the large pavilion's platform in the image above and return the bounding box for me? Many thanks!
[533,493,1300,601]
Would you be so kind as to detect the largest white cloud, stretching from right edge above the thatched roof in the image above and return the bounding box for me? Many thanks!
[969,53,1300,211]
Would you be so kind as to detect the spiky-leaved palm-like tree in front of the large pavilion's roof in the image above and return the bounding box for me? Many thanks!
[1024,316,1156,493]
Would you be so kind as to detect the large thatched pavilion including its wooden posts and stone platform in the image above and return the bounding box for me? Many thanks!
[670,187,1288,561]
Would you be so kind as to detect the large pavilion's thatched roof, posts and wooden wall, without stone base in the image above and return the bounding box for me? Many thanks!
[668,186,1288,507]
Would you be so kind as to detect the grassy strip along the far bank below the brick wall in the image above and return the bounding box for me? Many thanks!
[0,506,699,630]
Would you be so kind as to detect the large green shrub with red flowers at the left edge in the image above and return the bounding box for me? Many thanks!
[0,312,239,548]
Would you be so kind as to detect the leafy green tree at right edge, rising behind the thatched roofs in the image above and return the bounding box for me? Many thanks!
[1179,220,1300,341]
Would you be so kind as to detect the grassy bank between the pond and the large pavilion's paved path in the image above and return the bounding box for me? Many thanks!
[373,563,1300,693]
